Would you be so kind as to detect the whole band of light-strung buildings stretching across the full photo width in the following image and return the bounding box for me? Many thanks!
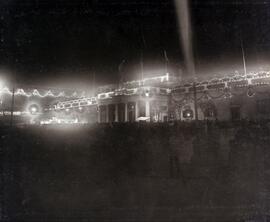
[0,71,270,124]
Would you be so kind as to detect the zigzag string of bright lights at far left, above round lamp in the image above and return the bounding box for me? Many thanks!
[0,87,85,98]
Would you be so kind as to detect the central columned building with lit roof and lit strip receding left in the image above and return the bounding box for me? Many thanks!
[55,74,176,123]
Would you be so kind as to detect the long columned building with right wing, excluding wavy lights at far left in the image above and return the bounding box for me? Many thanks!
[51,72,270,123]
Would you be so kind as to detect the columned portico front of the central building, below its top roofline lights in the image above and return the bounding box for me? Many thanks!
[98,87,169,123]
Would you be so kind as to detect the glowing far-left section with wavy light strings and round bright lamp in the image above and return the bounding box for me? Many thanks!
[0,86,84,125]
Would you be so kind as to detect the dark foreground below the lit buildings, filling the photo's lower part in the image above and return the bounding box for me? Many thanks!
[0,122,270,222]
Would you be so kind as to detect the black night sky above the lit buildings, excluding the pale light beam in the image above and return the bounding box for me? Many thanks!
[0,0,270,84]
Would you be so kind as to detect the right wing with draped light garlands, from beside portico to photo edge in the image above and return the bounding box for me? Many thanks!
[171,71,270,121]
